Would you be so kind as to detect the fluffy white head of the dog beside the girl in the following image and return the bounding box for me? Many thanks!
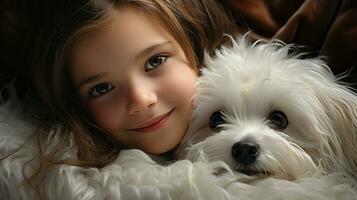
[183,35,357,179]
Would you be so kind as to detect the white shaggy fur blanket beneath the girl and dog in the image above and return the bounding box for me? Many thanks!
[0,91,357,200]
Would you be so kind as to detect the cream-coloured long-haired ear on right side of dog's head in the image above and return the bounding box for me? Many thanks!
[314,77,357,180]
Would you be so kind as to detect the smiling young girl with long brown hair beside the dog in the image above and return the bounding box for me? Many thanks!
[16,0,234,191]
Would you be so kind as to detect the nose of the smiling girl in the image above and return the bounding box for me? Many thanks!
[128,86,157,115]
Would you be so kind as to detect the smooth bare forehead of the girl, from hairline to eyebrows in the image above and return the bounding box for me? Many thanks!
[71,7,182,82]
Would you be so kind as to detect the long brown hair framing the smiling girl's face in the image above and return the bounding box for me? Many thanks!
[21,0,235,196]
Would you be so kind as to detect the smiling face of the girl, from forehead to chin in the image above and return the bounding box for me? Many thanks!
[71,7,197,154]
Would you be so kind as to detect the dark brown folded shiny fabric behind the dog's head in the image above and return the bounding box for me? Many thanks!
[221,0,357,88]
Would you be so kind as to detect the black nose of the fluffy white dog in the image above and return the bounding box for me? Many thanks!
[231,140,259,165]
